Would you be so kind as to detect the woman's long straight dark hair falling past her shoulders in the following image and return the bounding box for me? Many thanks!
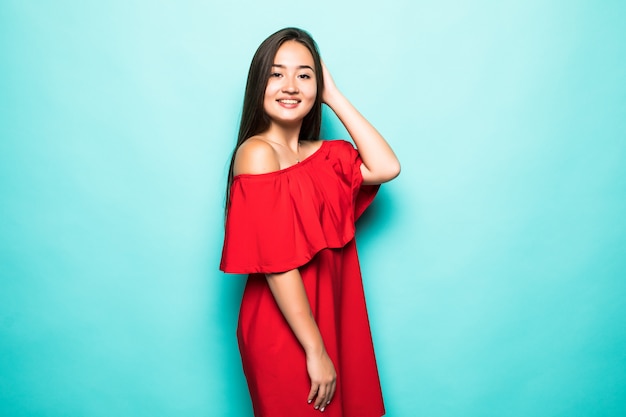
[226,28,324,211]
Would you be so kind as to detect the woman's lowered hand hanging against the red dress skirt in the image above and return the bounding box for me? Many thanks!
[306,351,337,411]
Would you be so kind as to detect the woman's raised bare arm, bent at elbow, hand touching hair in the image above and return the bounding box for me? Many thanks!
[322,63,400,184]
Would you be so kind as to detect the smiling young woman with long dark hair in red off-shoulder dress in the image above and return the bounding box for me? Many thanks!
[220,28,400,417]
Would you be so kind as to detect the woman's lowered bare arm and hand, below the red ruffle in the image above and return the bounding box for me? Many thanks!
[266,269,337,411]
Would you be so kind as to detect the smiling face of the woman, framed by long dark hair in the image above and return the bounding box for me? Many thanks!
[263,41,317,125]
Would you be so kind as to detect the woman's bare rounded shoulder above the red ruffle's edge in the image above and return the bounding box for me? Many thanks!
[233,136,280,175]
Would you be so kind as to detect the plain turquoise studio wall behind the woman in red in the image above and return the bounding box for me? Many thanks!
[0,0,626,417]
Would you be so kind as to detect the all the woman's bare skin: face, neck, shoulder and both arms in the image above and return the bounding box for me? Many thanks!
[234,41,400,412]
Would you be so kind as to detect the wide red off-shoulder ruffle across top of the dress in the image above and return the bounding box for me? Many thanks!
[220,140,379,274]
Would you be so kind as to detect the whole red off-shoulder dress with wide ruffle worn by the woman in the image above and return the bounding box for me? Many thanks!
[220,141,385,417]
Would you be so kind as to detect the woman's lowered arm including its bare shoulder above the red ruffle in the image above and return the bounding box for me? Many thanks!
[233,138,337,411]
